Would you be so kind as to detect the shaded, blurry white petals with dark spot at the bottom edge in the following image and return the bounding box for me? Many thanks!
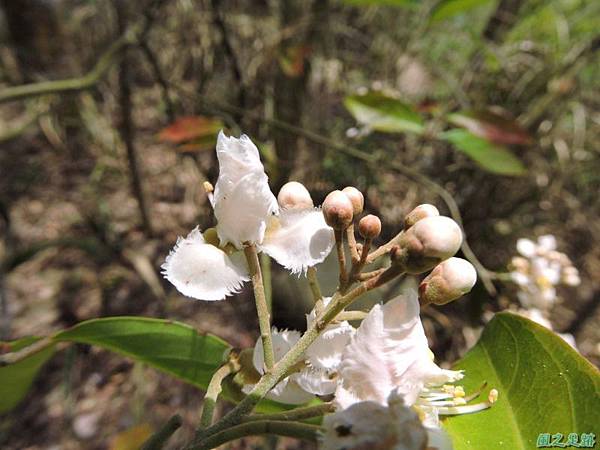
[319,394,432,450]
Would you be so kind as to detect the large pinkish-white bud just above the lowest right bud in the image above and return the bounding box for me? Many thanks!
[392,216,462,274]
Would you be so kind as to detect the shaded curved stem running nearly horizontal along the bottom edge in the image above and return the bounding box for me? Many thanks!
[189,420,321,450]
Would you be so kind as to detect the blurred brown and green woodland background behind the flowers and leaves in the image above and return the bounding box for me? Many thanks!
[0,0,600,448]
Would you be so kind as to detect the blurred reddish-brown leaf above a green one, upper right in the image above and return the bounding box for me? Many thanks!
[448,110,531,145]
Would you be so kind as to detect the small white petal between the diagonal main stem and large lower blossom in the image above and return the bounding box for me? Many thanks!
[297,297,356,395]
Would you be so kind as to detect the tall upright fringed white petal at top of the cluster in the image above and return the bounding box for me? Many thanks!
[213,132,278,248]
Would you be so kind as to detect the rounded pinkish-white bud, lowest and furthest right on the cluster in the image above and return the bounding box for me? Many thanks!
[419,258,477,305]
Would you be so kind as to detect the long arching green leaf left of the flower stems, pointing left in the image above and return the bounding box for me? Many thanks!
[54,317,231,388]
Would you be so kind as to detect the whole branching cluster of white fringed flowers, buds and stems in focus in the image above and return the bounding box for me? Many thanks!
[163,133,498,449]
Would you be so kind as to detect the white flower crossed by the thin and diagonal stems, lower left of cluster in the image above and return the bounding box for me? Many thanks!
[242,327,314,405]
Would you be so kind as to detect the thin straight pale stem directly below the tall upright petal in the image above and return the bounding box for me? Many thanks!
[244,244,275,371]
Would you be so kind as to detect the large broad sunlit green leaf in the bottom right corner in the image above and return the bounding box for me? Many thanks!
[444,313,600,450]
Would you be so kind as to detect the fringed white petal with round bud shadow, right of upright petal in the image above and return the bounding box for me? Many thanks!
[261,208,335,274]
